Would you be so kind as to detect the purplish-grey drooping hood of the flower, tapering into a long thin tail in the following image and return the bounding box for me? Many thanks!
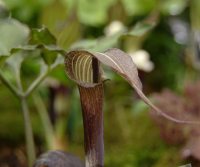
[94,49,200,124]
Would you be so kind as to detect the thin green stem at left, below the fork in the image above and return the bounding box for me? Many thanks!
[21,97,35,167]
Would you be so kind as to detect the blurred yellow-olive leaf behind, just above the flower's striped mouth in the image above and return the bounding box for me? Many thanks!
[39,1,81,49]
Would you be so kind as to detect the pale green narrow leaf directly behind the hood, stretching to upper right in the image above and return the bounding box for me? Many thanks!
[71,13,158,52]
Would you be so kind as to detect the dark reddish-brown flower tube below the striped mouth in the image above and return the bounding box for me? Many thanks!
[79,84,104,167]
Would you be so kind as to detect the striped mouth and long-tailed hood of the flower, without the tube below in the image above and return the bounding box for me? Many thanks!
[65,48,200,124]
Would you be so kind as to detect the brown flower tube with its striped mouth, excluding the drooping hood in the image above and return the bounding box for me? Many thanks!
[65,51,104,167]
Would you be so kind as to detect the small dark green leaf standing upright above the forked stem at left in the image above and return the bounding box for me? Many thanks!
[29,27,56,45]
